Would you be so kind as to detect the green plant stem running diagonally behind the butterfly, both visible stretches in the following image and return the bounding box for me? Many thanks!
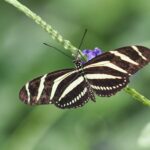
[5,0,150,106]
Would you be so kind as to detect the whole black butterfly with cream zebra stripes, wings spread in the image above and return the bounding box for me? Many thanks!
[19,46,150,108]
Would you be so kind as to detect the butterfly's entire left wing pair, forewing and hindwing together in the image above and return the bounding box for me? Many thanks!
[19,69,88,108]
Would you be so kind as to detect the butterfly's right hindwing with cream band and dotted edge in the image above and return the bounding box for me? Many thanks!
[84,66,129,96]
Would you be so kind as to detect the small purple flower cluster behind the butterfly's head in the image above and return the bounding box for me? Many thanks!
[82,47,102,61]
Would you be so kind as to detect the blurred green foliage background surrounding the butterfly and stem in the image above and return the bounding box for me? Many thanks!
[0,0,150,150]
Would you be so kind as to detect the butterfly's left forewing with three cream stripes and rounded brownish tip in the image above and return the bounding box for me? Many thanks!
[19,69,74,105]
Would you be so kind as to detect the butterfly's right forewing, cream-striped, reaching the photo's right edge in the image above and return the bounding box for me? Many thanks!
[84,46,150,76]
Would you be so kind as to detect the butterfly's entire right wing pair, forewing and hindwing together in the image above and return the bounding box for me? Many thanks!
[84,46,150,96]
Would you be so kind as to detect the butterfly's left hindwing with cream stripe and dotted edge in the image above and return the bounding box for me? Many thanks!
[55,75,89,108]
